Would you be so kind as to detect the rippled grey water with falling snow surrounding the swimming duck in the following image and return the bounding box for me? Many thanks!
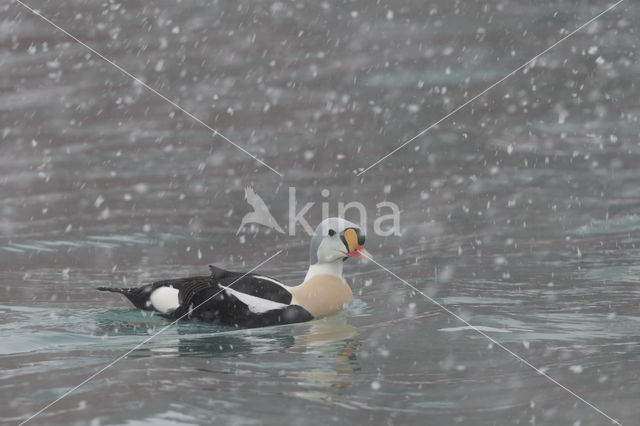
[0,0,640,425]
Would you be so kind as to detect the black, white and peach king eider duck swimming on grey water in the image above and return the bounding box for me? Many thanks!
[98,218,369,327]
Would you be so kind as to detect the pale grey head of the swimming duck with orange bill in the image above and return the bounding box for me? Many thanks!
[309,217,370,265]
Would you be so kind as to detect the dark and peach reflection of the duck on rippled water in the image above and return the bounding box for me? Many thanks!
[100,313,360,405]
